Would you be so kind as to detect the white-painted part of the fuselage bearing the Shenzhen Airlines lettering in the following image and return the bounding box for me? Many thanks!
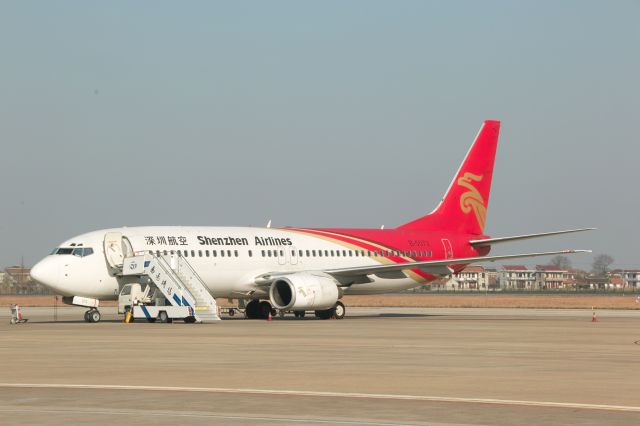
[32,226,422,299]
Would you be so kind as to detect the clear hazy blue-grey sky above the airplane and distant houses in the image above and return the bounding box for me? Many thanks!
[0,0,640,269]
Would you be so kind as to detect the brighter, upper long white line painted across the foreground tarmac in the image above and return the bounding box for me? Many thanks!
[0,383,640,412]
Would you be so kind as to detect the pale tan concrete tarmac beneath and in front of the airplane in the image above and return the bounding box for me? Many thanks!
[0,307,640,425]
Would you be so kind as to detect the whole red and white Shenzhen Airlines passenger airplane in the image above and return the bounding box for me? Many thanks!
[31,120,595,322]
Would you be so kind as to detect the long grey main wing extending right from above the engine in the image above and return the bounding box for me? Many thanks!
[323,250,591,277]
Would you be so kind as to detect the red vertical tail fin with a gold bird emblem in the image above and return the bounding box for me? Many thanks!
[400,120,500,235]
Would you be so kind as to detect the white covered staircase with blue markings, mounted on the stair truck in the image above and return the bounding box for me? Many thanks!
[122,253,220,323]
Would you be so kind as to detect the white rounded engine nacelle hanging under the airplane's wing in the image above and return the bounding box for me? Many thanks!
[269,272,340,311]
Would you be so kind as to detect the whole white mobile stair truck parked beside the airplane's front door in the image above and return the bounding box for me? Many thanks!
[118,253,220,322]
